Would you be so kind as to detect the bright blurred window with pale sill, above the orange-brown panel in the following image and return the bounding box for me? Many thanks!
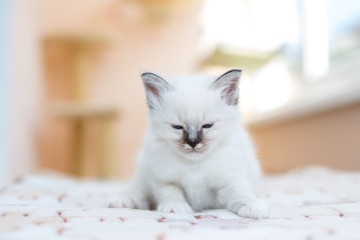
[203,0,360,123]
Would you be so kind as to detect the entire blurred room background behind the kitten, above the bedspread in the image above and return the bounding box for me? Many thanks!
[0,0,360,185]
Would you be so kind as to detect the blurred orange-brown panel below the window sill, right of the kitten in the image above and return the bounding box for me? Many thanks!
[250,101,360,172]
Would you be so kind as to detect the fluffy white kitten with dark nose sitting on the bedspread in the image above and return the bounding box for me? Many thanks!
[108,69,269,219]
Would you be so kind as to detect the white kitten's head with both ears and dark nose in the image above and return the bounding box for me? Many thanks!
[142,69,241,160]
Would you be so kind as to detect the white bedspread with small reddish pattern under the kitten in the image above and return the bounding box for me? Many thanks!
[0,167,360,240]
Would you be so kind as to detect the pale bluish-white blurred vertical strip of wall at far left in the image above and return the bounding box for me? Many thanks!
[0,0,41,184]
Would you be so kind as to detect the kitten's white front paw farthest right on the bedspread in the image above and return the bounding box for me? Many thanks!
[232,201,270,219]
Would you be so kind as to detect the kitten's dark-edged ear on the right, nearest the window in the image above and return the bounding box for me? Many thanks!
[211,69,241,105]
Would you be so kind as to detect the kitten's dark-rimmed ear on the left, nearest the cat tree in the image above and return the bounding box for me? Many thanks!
[141,72,171,109]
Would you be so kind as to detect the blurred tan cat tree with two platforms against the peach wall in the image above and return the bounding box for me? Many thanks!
[46,34,117,176]
